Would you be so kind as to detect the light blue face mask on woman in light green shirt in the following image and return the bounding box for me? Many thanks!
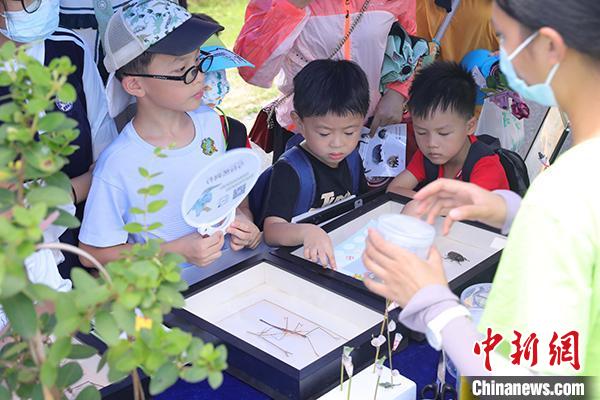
[500,32,560,107]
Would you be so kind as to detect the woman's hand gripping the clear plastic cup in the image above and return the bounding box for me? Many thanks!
[363,229,448,307]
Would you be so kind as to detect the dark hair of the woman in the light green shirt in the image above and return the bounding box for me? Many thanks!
[496,0,600,60]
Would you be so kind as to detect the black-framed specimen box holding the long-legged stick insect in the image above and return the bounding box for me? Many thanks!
[170,254,384,399]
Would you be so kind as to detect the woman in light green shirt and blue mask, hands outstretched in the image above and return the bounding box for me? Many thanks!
[363,0,600,375]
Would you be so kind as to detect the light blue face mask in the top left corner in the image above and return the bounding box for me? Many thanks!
[0,0,59,43]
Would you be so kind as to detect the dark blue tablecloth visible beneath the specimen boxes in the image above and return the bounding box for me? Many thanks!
[155,341,453,400]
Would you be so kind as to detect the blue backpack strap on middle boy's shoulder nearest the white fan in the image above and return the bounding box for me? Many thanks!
[279,147,317,216]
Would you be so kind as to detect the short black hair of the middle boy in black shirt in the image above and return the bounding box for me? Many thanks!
[294,60,369,118]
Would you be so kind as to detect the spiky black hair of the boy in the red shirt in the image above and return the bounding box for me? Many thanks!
[407,61,477,119]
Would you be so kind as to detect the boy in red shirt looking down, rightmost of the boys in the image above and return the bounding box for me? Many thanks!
[388,61,509,197]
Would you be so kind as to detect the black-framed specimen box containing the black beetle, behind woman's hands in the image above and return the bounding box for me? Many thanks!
[273,193,506,300]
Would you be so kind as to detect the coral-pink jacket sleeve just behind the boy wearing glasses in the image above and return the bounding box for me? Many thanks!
[233,0,312,88]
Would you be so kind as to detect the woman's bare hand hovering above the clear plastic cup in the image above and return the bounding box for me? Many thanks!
[414,179,507,235]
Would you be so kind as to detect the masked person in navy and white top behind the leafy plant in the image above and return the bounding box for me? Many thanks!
[0,0,117,277]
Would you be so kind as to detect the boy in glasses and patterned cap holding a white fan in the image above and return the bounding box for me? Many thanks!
[79,0,260,266]
